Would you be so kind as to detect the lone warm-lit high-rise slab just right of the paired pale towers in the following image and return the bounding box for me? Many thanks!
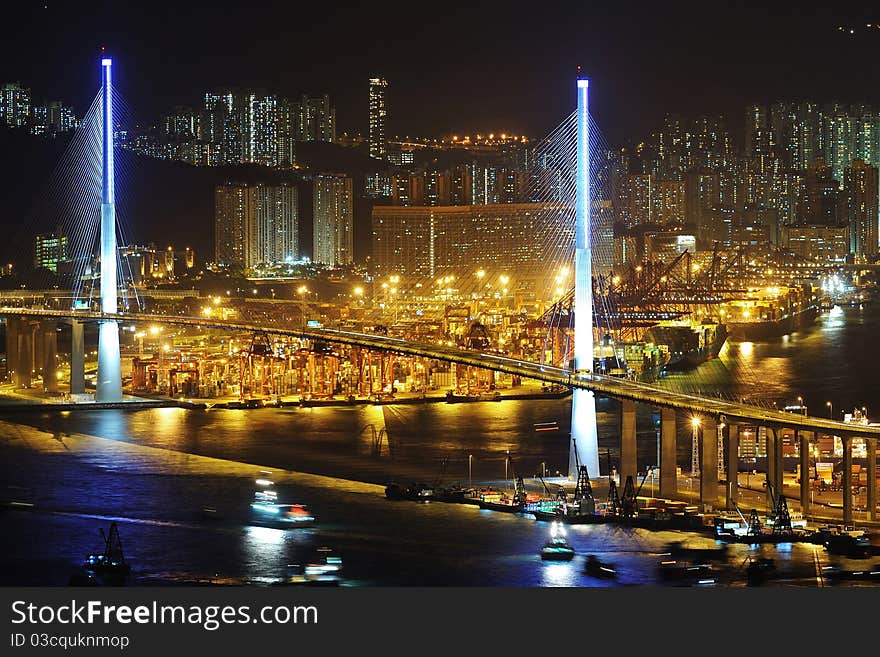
[312,174,354,267]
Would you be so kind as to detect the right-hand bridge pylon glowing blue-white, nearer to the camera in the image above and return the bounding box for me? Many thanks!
[568,75,599,479]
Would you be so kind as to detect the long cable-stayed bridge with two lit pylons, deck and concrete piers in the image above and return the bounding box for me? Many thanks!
[0,59,880,519]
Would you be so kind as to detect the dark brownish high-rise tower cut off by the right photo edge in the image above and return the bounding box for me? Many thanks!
[843,160,878,258]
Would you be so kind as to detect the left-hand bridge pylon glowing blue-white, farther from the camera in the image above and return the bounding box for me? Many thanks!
[95,58,122,402]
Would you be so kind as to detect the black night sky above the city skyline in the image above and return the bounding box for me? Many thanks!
[0,0,880,143]
